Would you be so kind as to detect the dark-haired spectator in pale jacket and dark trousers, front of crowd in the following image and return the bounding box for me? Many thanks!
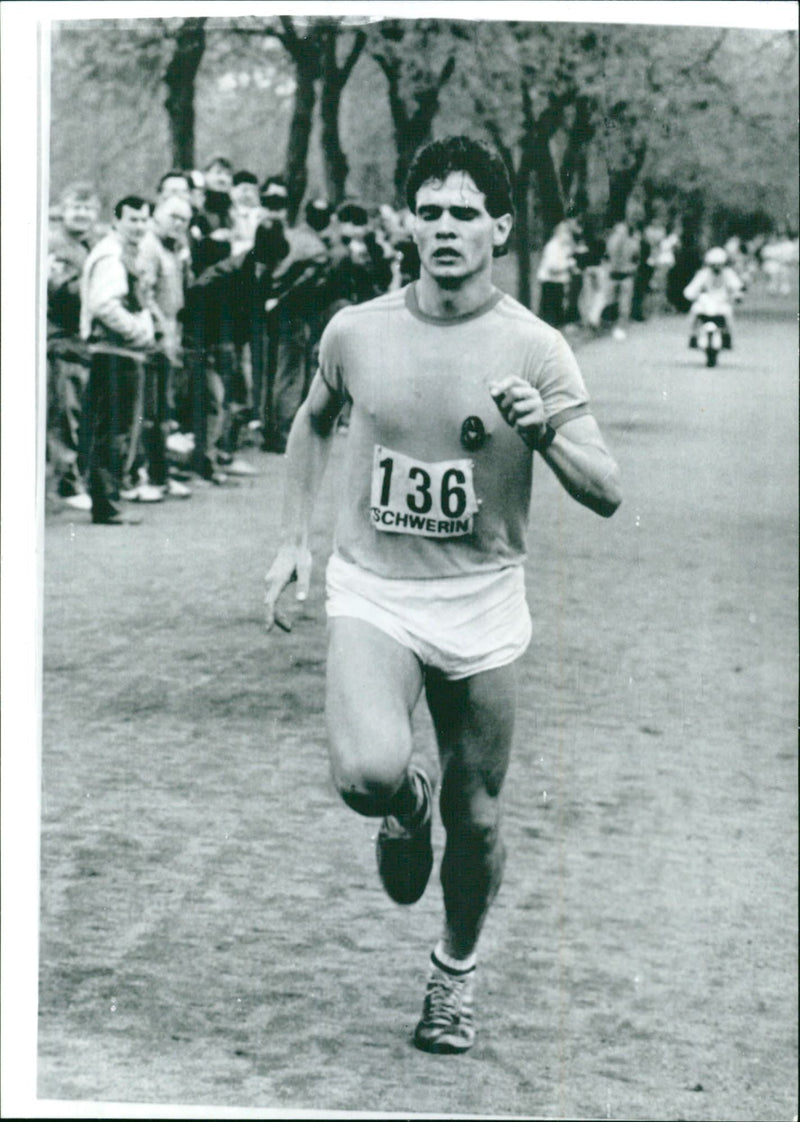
[81,195,157,525]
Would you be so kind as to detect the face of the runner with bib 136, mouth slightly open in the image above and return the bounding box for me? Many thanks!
[414,172,511,287]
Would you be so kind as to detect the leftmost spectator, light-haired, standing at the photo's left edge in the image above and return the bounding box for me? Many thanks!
[47,183,100,511]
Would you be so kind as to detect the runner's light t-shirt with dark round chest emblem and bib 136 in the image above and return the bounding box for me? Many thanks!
[320,284,589,578]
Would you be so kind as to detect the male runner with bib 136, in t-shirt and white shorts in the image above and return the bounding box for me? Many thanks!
[266,137,620,1052]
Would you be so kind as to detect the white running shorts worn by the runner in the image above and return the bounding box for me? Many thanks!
[325,554,533,681]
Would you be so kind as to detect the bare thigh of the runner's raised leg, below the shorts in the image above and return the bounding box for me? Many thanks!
[325,616,422,788]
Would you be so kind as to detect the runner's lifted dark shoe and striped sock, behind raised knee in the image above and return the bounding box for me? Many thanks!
[376,767,433,904]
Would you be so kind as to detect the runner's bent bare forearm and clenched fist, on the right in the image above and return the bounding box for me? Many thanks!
[491,376,622,518]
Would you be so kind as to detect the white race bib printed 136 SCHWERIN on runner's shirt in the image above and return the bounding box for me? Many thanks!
[370,444,478,537]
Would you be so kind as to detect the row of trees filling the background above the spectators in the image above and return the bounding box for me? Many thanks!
[50,16,798,305]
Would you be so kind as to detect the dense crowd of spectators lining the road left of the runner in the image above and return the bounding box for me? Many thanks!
[47,157,419,525]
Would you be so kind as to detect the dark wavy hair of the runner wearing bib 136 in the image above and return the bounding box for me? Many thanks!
[405,136,514,218]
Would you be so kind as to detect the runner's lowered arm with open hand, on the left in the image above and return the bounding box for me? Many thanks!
[264,374,342,631]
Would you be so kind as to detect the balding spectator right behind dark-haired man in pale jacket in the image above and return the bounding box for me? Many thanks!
[138,192,192,498]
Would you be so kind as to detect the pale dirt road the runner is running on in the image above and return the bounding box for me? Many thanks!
[39,296,798,1120]
